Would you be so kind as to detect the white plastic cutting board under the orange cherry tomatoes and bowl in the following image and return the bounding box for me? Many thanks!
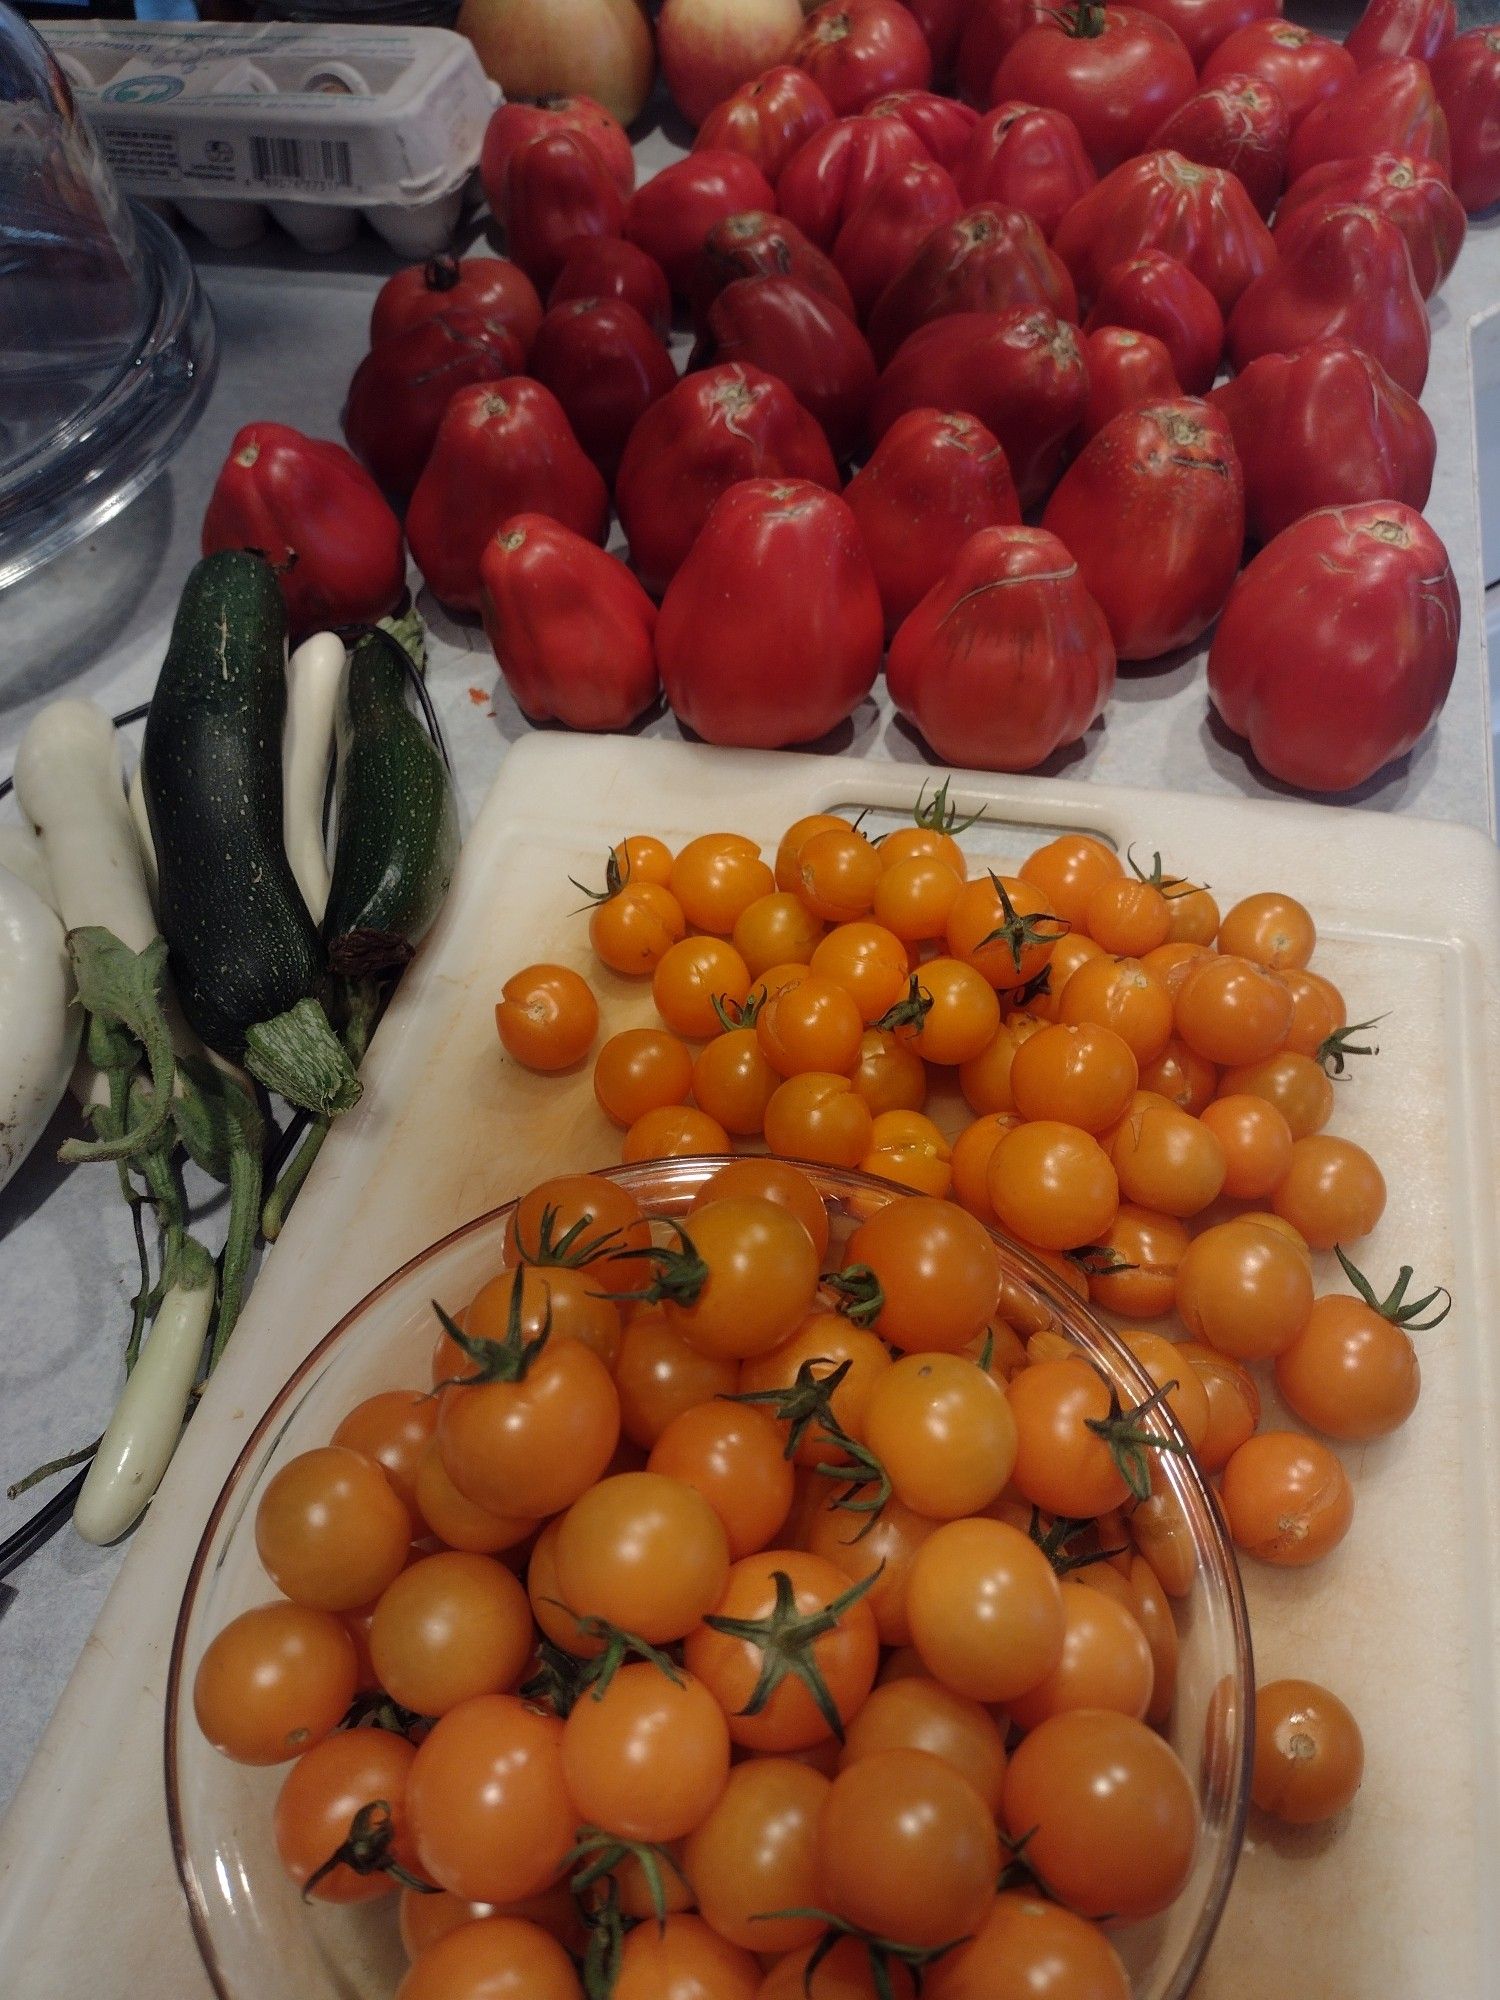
[0,734,1500,2000]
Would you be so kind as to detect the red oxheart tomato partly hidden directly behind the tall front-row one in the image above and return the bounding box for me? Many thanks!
[614,362,838,596]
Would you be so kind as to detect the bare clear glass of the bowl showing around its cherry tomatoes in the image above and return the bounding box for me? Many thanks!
[166,1158,1254,2000]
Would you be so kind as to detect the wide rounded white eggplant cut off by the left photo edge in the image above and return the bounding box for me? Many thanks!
[0,868,84,1188]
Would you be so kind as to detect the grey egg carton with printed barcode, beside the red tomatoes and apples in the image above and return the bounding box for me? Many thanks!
[42,20,500,258]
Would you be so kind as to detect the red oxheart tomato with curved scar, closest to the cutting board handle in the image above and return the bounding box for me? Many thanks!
[886,526,1114,770]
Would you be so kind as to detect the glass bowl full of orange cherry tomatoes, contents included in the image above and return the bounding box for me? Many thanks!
[166,1158,1254,2000]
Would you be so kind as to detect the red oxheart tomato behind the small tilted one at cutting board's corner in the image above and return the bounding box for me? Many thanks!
[406,376,610,612]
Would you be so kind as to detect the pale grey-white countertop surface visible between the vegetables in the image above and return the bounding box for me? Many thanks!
[0,117,1500,1806]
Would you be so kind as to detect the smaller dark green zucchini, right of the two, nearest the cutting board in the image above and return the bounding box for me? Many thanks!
[324,628,458,978]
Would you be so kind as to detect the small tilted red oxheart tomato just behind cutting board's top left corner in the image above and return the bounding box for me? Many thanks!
[480,514,658,730]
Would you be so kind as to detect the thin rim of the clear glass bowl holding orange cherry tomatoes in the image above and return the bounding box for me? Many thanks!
[162,1154,1256,2000]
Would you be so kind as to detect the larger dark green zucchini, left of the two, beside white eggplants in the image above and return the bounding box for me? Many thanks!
[142,550,324,1060]
